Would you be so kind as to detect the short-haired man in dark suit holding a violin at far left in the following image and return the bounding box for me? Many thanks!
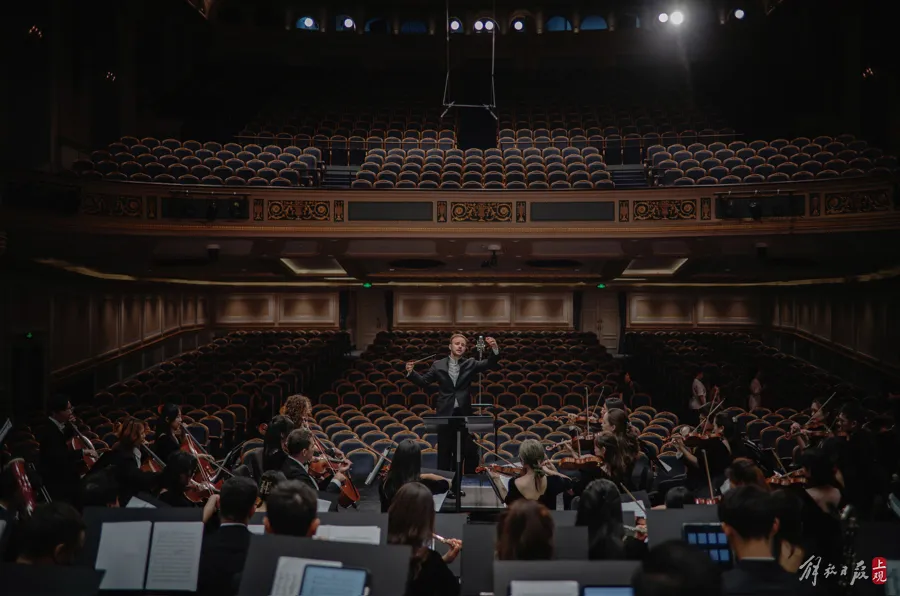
[39,395,97,504]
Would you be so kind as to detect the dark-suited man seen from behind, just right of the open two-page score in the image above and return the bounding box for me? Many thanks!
[197,476,257,596]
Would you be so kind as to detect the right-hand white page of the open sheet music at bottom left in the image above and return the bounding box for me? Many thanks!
[146,522,203,592]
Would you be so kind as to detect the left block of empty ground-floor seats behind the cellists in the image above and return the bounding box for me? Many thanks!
[0,331,349,463]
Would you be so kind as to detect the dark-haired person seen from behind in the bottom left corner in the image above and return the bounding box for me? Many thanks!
[16,502,85,566]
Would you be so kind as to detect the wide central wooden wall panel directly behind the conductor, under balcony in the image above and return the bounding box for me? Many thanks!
[394,292,574,329]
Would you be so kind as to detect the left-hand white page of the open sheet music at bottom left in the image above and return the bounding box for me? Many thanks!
[94,521,153,590]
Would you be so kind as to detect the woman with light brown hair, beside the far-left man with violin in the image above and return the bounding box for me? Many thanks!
[89,417,159,505]
